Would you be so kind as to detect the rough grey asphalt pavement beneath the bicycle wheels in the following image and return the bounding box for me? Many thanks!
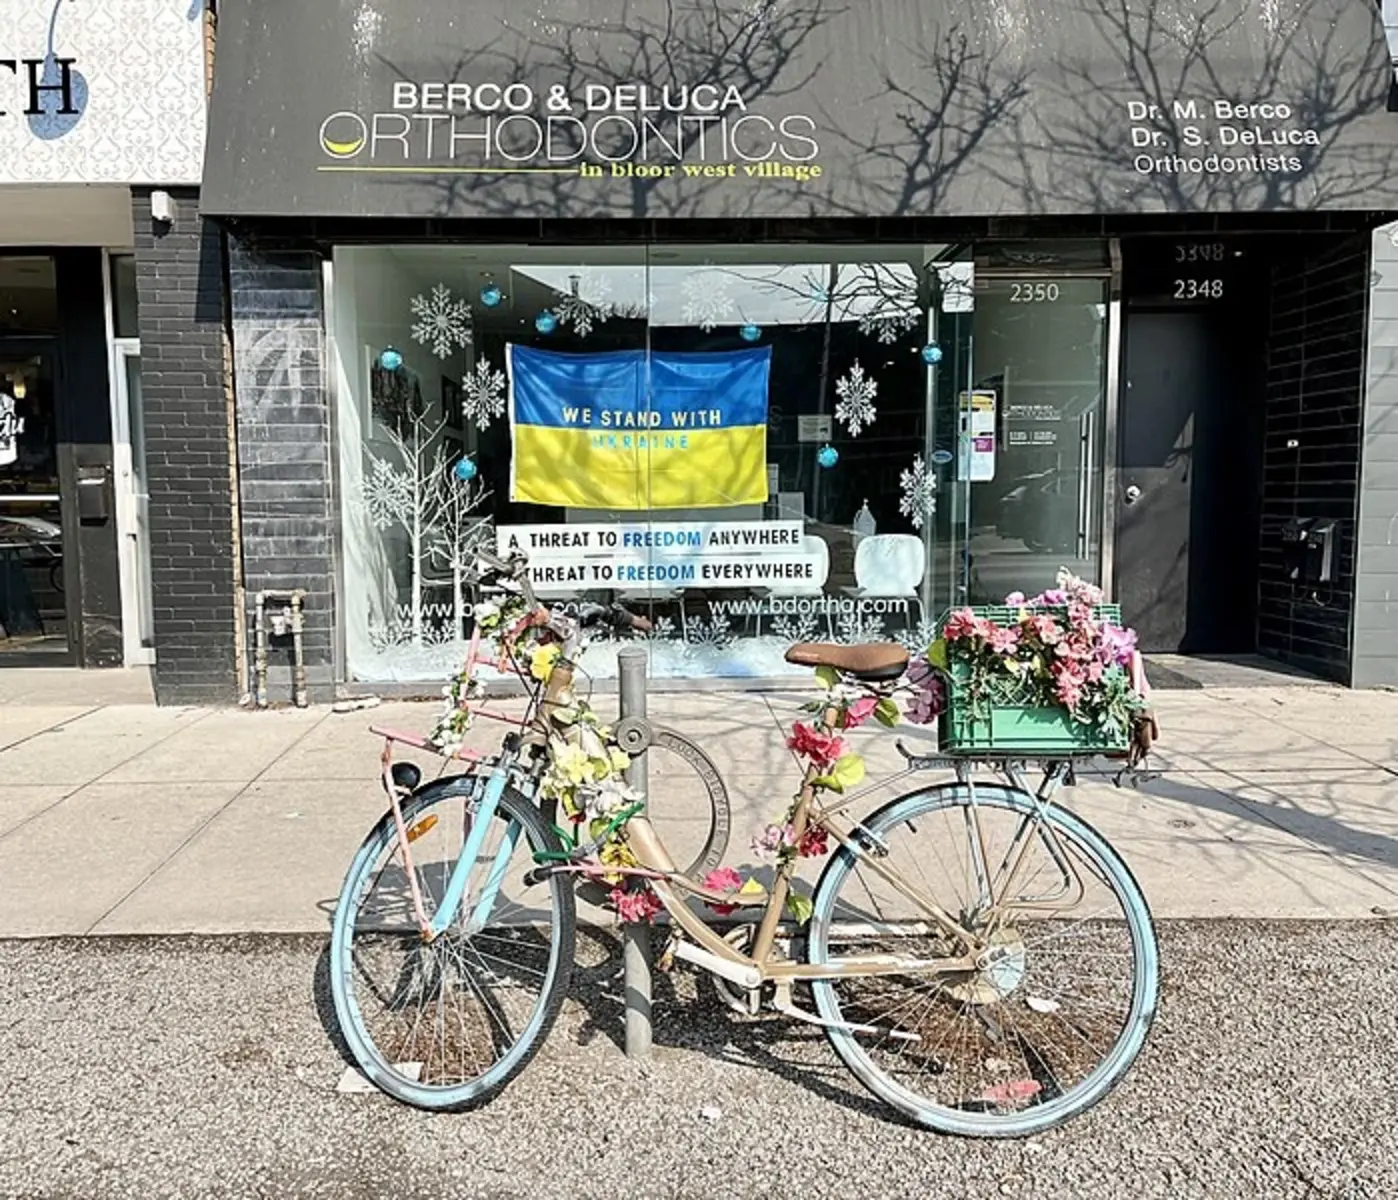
[0,920,1398,1200]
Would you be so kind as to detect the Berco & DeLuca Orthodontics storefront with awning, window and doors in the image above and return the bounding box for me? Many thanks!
[204,0,1398,688]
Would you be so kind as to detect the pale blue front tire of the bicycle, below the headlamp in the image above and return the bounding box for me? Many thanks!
[330,775,577,1112]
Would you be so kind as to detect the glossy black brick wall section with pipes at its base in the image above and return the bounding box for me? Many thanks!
[229,238,336,702]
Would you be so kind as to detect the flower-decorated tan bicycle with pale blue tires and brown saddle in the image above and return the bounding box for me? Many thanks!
[331,548,1159,1137]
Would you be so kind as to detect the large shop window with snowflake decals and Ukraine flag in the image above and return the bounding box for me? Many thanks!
[333,245,1100,681]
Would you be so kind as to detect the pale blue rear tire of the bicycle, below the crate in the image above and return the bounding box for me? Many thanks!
[807,783,1159,1138]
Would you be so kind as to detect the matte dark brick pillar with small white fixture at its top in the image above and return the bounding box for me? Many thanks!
[131,189,239,703]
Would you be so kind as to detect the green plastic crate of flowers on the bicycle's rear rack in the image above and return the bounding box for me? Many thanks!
[938,604,1128,757]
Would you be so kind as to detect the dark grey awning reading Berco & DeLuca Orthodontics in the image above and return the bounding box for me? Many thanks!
[204,0,1398,218]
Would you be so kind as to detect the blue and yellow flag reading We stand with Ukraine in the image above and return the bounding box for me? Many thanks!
[506,345,772,510]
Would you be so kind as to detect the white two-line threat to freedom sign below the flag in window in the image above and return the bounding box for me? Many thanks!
[496,520,822,590]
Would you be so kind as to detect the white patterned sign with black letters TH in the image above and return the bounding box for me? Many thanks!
[0,0,206,184]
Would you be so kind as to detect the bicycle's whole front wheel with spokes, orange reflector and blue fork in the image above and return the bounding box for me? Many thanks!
[330,776,576,1110]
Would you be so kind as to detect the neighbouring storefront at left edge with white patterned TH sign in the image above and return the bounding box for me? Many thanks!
[0,0,209,669]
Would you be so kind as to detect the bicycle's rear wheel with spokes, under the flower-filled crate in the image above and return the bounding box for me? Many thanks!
[807,783,1159,1137]
